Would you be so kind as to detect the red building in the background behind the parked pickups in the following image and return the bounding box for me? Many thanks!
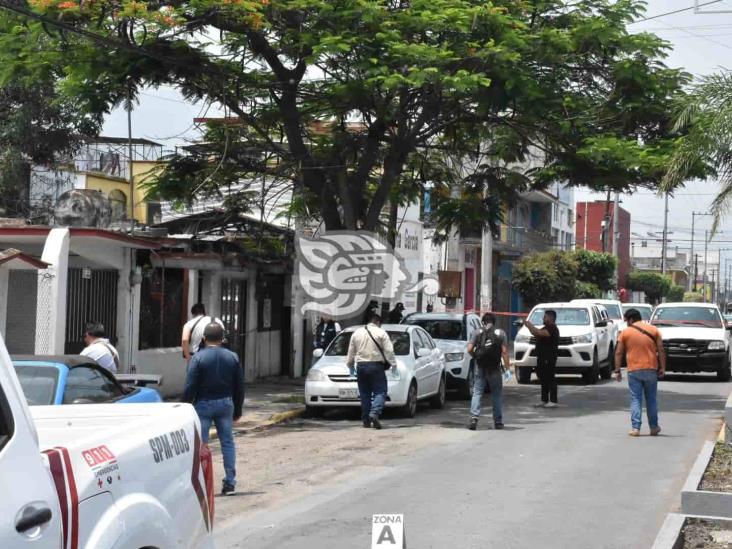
[575,200,630,288]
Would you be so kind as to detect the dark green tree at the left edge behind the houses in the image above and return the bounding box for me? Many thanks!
[0,14,102,217]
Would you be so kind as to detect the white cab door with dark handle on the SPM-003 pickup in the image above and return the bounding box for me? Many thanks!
[0,356,60,549]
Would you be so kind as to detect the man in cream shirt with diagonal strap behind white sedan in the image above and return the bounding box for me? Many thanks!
[346,313,396,429]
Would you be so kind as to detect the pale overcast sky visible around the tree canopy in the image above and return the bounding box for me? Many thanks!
[104,0,732,263]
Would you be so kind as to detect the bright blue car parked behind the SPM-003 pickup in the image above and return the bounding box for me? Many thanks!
[12,355,163,406]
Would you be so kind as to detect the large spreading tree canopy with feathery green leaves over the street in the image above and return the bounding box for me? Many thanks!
[0,0,700,230]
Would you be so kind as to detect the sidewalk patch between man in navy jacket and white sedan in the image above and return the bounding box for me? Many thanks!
[233,377,305,434]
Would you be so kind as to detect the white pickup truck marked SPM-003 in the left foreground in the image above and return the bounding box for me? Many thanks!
[0,340,214,549]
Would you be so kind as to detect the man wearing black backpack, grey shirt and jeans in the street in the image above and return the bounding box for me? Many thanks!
[468,313,511,431]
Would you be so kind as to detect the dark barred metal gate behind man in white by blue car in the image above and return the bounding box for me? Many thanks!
[65,269,119,354]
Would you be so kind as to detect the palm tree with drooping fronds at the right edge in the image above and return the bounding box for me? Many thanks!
[662,71,732,232]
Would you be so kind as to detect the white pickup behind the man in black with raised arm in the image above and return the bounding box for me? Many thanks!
[513,302,615,384]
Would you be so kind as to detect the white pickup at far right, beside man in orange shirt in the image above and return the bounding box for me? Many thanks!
[651,303,732,381]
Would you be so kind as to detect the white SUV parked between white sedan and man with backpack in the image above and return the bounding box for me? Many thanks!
[402,313,481,398]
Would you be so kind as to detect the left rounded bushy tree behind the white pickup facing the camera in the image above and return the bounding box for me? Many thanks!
[512,251,577,307]
